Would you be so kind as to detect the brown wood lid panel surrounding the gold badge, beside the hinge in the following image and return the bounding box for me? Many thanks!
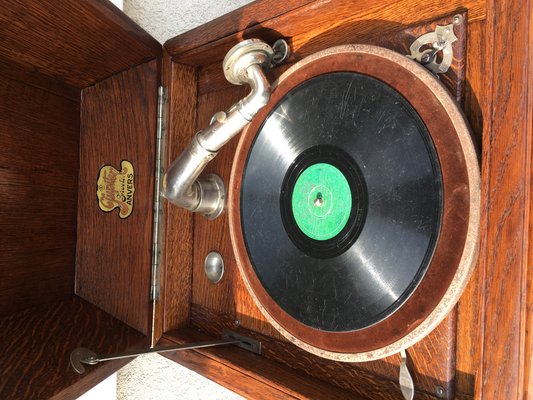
[76,61,158,334]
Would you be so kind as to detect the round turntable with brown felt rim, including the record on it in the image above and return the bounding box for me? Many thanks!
[230,46,477,361]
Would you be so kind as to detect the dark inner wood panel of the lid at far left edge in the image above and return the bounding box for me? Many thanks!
[0,72,80,316]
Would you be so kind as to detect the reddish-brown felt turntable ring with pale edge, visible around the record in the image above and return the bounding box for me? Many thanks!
[229,46,479,361]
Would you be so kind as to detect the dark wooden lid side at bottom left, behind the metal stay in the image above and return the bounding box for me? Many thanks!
[0,296,147,400]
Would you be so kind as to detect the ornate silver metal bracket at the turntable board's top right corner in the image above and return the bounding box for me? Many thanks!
[407,15,462,74]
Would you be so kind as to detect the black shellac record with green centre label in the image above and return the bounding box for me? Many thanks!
[241,72,442,332]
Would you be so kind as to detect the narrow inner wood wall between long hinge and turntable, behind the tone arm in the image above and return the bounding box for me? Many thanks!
[163,56,197,331]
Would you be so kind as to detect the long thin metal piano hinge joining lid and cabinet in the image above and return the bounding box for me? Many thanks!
[150,86,167,301]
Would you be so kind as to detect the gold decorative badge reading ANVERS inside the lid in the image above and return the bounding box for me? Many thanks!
[96,160,135,218]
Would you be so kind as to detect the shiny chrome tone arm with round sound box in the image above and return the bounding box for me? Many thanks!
[161,39,272,219]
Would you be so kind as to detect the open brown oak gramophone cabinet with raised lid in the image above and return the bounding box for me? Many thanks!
[0,0,533,399]
